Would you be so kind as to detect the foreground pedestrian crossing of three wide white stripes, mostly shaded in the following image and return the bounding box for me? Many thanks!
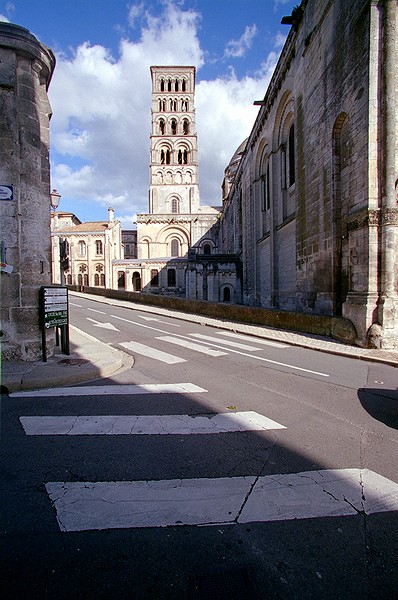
[11,382,398,532]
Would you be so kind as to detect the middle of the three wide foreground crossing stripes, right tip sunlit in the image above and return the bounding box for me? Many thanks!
[19,411,286,435]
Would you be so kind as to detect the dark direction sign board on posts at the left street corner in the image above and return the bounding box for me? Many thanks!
[40,285,70,362]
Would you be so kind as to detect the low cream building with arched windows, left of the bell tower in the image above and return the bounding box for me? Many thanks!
[51,208,123,289]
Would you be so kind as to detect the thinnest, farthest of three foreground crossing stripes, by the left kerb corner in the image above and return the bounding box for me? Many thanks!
[10,383,207,398]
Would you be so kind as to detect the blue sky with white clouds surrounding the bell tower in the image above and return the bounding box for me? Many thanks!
[0,0,299,228]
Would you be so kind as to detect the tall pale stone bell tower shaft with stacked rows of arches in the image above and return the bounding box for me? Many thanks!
[149,66,199,215]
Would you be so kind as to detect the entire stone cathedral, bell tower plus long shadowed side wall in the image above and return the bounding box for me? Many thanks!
[51,0,398,348]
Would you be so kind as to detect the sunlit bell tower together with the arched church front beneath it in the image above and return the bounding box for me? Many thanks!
[113,66,235,300]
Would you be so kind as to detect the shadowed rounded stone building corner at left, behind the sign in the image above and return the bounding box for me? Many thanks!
[0,23,55,360]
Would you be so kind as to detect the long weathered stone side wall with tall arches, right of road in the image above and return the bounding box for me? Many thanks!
[218,0,398,348]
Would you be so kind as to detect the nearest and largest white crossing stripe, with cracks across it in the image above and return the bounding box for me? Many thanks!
[46,469,398,531]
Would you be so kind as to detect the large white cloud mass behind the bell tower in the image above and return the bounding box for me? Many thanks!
[49,2,276,228]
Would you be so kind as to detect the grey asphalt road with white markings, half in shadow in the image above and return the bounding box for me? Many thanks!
[0,298,398,599]
